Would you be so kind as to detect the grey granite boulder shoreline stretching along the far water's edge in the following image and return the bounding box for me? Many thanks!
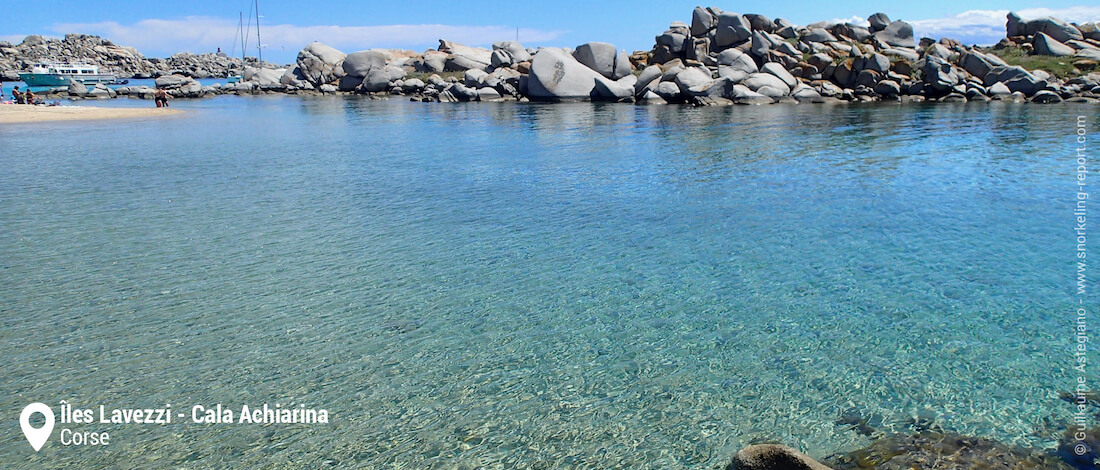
[0,7,1100,106]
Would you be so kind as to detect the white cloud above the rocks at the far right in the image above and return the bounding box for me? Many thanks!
[906,7,1100,45]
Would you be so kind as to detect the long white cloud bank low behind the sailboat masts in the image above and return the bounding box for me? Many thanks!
[47,17,565,62]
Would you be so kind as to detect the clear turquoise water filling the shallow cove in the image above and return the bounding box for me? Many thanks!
[0,97,1095,468]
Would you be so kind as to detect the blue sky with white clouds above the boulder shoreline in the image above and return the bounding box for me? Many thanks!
[0,0,1100,63]
